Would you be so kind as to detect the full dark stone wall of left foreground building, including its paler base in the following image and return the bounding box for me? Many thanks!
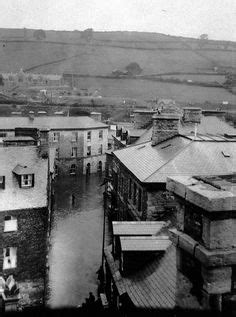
[0,209,48,306]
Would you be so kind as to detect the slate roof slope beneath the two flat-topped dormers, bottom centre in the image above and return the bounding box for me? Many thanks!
[105,245,201,309]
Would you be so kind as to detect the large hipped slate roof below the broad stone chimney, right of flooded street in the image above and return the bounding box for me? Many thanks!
[113,135,236,183]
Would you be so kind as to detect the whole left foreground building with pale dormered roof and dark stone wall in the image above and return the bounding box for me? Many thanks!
[0,131,53,306]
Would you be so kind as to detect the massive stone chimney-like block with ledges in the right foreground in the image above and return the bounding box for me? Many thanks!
[167,173,236,313]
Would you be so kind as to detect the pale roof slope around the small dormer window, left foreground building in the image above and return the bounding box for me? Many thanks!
[0,146,48,211]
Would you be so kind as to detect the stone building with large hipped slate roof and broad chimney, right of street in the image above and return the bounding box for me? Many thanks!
[105,114,236,224]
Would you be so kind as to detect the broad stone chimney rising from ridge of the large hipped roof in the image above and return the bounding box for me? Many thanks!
[152,113,179,146]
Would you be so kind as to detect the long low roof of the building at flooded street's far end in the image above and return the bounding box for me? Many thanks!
[0,116,108,130]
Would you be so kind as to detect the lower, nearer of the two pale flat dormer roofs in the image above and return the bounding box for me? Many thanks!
[120,236,171,252]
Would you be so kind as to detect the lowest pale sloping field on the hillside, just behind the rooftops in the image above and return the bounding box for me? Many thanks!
[63,78,236,105]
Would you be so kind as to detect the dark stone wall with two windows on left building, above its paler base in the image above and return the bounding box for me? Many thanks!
[0,208,48,281]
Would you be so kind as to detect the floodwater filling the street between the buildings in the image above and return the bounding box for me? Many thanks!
[48,175,104,308]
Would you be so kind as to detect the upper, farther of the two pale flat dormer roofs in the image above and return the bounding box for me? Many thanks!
[112,221,165,236]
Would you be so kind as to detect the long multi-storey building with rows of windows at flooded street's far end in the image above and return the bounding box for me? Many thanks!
[0,116,108,175]
